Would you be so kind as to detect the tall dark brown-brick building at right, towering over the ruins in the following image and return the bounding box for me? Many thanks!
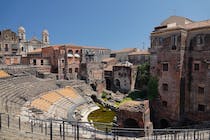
[150,16,210,128]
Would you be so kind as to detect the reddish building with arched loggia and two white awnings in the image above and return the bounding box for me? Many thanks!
[42,45,81,79]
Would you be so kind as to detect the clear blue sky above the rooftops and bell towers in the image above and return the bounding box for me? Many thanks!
[0,0,210,50]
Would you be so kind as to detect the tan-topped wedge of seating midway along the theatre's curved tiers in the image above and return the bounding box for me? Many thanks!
[29,86,84,118]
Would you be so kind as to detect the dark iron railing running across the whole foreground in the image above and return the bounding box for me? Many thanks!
[0,113,210,140]
